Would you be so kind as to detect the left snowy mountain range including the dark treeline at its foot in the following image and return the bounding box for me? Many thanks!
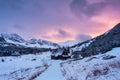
[0,34,59,56]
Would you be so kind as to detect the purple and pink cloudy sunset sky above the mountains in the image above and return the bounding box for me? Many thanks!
[0,0,120,42]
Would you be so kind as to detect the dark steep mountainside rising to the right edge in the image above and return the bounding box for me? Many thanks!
[73,23,120,57]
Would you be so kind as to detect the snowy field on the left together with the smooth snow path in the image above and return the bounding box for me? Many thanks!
[0,52,65,80]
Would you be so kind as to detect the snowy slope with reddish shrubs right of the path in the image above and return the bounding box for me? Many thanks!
[61,48,120,80]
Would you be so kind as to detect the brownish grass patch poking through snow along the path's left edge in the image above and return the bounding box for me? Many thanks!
[8,66,49,80]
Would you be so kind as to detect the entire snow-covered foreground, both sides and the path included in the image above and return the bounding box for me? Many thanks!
[0,48,120,80]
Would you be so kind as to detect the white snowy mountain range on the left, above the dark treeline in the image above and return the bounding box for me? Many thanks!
[0,33,59,48]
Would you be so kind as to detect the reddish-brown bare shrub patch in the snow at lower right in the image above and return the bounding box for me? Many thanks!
[86,60,120,80]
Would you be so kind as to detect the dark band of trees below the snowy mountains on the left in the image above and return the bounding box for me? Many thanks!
[0,43,51,56]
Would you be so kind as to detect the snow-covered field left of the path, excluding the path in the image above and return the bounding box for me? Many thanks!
[0,52,50,80]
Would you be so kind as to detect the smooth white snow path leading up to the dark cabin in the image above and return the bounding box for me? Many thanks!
[35,60,65,80]
